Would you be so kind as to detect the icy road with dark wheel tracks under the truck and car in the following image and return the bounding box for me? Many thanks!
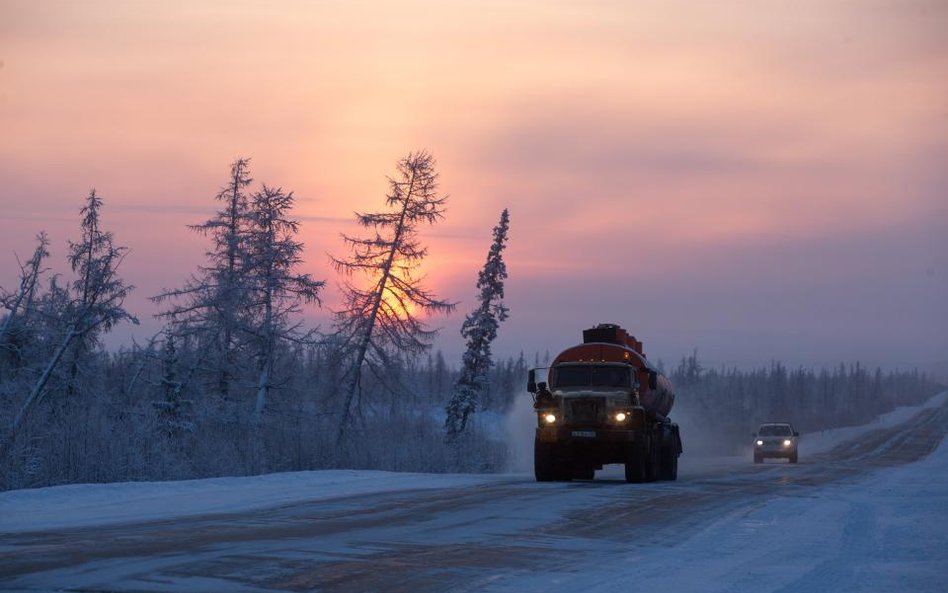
[0,398,948,593]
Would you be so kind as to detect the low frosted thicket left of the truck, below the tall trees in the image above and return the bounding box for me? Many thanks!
[0,332,528,489]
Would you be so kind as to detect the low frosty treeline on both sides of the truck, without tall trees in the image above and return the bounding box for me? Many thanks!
[0,336,944,489]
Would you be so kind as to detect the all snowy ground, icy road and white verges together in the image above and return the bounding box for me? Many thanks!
[0,394,948,593]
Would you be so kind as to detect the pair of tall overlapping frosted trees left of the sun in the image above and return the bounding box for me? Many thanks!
[153,158,324,422]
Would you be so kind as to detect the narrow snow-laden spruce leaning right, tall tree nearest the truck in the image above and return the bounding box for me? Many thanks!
[444,208,510,439]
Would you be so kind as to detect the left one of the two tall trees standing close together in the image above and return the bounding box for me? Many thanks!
[152,158,253,400]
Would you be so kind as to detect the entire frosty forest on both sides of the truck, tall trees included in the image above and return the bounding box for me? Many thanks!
[0,152,943,490]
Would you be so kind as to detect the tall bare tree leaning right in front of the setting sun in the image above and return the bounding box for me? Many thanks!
[330,151,455,443]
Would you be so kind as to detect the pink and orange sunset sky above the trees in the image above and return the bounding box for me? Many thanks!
[0,0,948,367]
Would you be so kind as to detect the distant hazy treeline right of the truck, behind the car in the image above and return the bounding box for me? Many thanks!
[670,352,945,454]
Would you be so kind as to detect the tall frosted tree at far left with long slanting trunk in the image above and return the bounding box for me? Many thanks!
[0,190,138,456]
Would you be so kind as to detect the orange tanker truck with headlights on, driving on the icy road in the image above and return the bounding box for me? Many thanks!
[527,323,682,483]
